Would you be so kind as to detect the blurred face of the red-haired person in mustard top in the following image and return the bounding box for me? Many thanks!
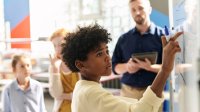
[52,37,64,59]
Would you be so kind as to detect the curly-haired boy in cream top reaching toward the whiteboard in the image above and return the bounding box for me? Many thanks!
[62,24,184,112]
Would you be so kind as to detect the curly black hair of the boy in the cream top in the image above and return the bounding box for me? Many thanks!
[61,23,112,72]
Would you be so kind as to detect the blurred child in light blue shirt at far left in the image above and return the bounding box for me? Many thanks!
[2,54,46,112]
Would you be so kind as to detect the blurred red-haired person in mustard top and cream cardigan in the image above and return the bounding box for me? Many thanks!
[49,29,79,112]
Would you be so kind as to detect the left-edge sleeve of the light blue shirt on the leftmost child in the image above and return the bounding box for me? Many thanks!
[1,87,11,112]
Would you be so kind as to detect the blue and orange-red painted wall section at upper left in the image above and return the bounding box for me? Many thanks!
[3,0,31,49]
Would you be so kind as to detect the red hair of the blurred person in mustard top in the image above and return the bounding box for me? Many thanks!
[49,28,69,41]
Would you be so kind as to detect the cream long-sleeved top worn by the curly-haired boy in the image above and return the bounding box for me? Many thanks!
[72,80,164,112]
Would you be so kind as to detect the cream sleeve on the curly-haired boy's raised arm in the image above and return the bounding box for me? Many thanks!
[86,85,163,112]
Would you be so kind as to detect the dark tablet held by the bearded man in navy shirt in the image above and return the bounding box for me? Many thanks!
[132,52,158,64]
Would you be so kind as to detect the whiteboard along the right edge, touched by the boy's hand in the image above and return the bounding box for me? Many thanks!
[169,0,200,112]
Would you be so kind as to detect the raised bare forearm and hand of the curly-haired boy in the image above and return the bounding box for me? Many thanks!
[151,32,183,97]
